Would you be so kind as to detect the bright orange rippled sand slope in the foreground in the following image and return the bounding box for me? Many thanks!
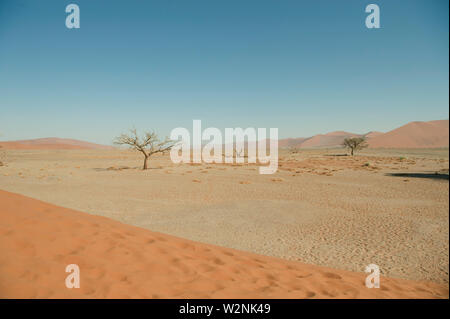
[0,191,448,298]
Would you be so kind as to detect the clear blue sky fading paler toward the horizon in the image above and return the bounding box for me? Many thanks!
[0,0,449,144]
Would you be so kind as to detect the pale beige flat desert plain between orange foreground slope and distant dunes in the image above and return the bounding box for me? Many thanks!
[0,150,449,285]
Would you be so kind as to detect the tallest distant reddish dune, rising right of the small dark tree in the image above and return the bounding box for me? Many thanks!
[368,120,449,148]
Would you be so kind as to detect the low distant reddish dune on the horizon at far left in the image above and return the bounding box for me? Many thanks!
[0,137,113,150]
